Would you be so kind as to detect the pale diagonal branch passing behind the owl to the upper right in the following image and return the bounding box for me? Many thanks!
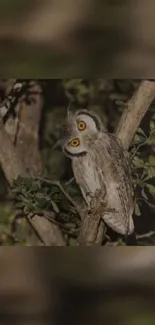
[78,80,155,246]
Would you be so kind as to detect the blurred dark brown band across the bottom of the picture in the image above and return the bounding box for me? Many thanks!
[0,247,155,325]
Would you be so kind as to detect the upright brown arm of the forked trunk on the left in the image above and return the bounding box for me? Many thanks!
[15,81,44,176]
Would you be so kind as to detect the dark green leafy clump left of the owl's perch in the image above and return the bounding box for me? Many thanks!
[10,177,79,241]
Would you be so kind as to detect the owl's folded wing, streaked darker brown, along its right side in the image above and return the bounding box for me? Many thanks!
[95,132,134,234]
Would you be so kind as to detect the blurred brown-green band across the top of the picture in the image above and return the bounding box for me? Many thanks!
[0,0,155,78]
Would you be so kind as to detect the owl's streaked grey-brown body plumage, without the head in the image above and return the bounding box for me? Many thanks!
[72,132,134,235]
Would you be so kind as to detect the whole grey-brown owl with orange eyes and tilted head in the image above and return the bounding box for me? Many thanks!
[62,109,134,243]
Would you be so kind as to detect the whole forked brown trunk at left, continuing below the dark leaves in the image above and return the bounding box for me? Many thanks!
[0,83,65,246]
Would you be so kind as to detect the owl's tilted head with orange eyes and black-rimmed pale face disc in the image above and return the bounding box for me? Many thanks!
[62,109,104,158]
